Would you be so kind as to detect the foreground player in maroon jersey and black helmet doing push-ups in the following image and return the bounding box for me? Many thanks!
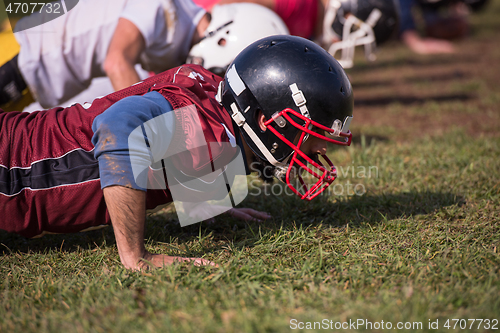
[0,35,353,269]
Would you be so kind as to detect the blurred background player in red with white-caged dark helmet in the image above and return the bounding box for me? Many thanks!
[195,0,399,68]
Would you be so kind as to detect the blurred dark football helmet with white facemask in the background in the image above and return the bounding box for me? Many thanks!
[323,0,400,68]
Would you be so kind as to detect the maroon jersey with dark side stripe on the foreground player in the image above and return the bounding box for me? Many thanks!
[0,65,235,237]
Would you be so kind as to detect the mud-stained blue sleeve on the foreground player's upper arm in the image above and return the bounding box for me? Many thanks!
[92,92,175,191]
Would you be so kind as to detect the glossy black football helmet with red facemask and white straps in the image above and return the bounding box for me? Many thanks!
[218,35,353,200]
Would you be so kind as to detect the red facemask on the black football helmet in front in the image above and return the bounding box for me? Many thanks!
[264,108,352,200]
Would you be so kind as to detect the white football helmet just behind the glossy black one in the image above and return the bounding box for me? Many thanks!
[186,3,289,76]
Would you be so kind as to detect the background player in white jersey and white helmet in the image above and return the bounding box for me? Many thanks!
[0,0,287,110]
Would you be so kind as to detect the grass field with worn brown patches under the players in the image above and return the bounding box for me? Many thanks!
[0,0,500,333]
